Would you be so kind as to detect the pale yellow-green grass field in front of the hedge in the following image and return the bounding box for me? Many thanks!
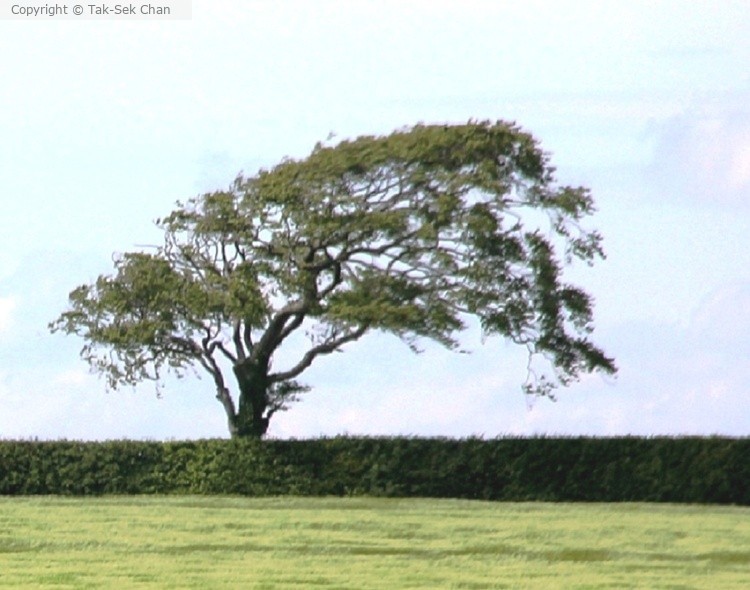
[0,496,750,590]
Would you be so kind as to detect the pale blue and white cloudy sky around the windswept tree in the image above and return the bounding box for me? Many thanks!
[0,0,750,440]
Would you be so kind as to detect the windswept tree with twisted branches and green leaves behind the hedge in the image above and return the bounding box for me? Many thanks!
[50,121,616,437]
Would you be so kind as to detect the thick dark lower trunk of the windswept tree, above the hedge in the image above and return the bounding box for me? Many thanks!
[235,360,269,438]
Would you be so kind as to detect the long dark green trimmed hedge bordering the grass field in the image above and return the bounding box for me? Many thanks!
[0,437,750,505]
